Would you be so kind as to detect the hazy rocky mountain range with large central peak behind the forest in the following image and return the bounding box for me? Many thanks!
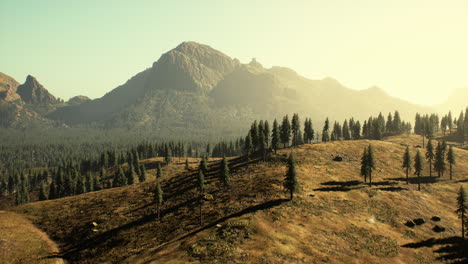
[0,42,459,134]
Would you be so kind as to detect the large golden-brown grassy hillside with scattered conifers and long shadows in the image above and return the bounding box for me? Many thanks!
[12,135,468,263]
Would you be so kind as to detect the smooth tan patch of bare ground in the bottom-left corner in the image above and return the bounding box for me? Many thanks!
[0,211,66,264]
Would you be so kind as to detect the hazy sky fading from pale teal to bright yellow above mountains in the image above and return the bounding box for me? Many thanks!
[0,0,468,104]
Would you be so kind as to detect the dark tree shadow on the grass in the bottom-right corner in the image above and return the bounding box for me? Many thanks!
[402,236,468,264]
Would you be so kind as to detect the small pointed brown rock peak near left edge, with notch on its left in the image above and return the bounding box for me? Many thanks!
[17,75,58,104]
